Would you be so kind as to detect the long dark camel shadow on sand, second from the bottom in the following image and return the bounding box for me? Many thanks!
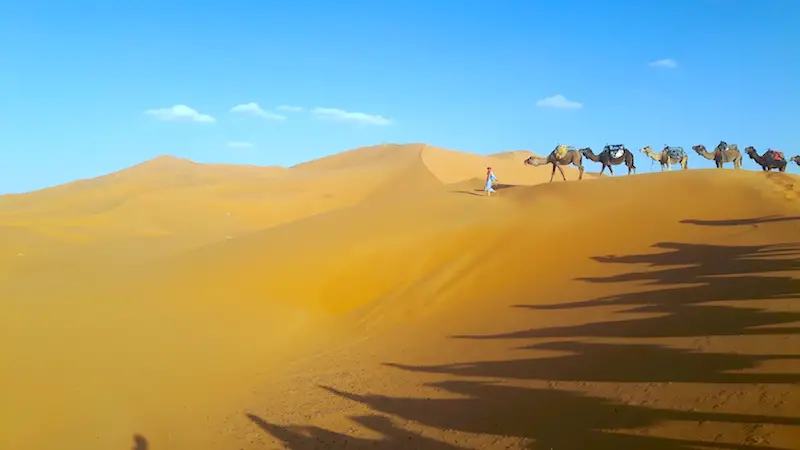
[318,380,800,450]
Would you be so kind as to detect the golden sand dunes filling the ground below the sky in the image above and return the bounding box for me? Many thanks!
[0,144,800,450]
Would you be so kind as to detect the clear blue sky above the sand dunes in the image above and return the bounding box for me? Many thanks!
[0,0,800,193]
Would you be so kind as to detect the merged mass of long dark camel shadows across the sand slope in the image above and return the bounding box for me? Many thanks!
[254,237,800,450]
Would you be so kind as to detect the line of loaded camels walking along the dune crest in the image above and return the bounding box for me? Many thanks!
[525,141,800,182]
